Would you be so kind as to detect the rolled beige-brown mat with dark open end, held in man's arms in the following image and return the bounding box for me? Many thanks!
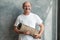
[17,23,39,36]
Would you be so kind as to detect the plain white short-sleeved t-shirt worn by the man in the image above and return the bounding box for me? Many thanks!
[14,13,43,40]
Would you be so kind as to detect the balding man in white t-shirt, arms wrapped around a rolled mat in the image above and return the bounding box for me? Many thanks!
[14,1,44,40]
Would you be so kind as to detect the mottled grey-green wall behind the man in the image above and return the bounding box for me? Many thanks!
[0,0,56,40]
